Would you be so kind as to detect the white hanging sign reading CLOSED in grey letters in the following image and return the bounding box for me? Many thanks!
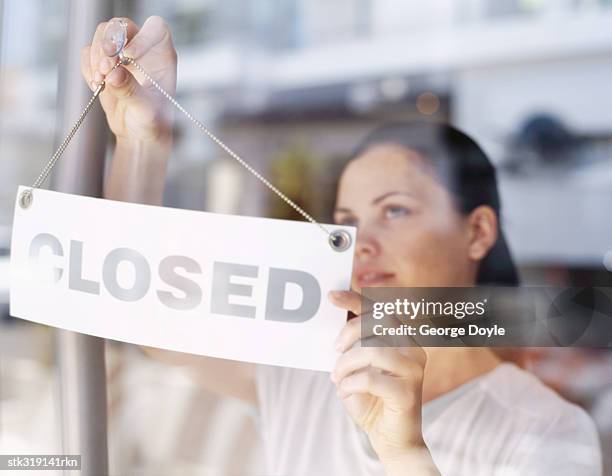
[10,187,355,371]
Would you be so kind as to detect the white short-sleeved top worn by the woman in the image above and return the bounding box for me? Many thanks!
[257,363,602,476]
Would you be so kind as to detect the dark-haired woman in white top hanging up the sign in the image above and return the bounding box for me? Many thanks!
[82,17,601,476]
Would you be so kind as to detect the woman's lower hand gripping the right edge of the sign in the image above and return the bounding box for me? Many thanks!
[329,291,437,475]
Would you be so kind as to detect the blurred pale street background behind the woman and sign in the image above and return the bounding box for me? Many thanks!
[0,0,612,475]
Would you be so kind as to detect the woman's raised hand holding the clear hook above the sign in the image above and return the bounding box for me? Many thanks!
[81,16,177,144]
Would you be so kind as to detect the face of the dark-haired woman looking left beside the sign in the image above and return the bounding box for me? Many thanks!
[334,144,478,291]
